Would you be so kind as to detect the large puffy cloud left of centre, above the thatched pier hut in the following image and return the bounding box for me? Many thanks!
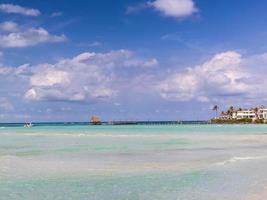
[22,50,158,101]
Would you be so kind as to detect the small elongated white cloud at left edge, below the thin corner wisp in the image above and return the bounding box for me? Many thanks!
[0,28,66,48]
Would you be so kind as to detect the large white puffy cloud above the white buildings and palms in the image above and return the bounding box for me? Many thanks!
[159,51,267,102]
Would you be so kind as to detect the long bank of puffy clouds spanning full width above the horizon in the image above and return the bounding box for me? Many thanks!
[0,47,267,109]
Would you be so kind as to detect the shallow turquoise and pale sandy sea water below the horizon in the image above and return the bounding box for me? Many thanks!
[0,124,267,200]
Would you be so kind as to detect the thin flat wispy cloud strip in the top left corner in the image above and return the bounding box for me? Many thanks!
[0,4,41,16]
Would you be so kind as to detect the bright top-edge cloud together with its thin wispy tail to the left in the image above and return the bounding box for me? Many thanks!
[126,0,198,18]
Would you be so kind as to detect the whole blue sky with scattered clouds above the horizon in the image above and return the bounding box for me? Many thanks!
[0,0,267,122]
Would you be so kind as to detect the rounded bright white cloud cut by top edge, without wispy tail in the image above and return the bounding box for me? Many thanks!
[149,0,197,18]
